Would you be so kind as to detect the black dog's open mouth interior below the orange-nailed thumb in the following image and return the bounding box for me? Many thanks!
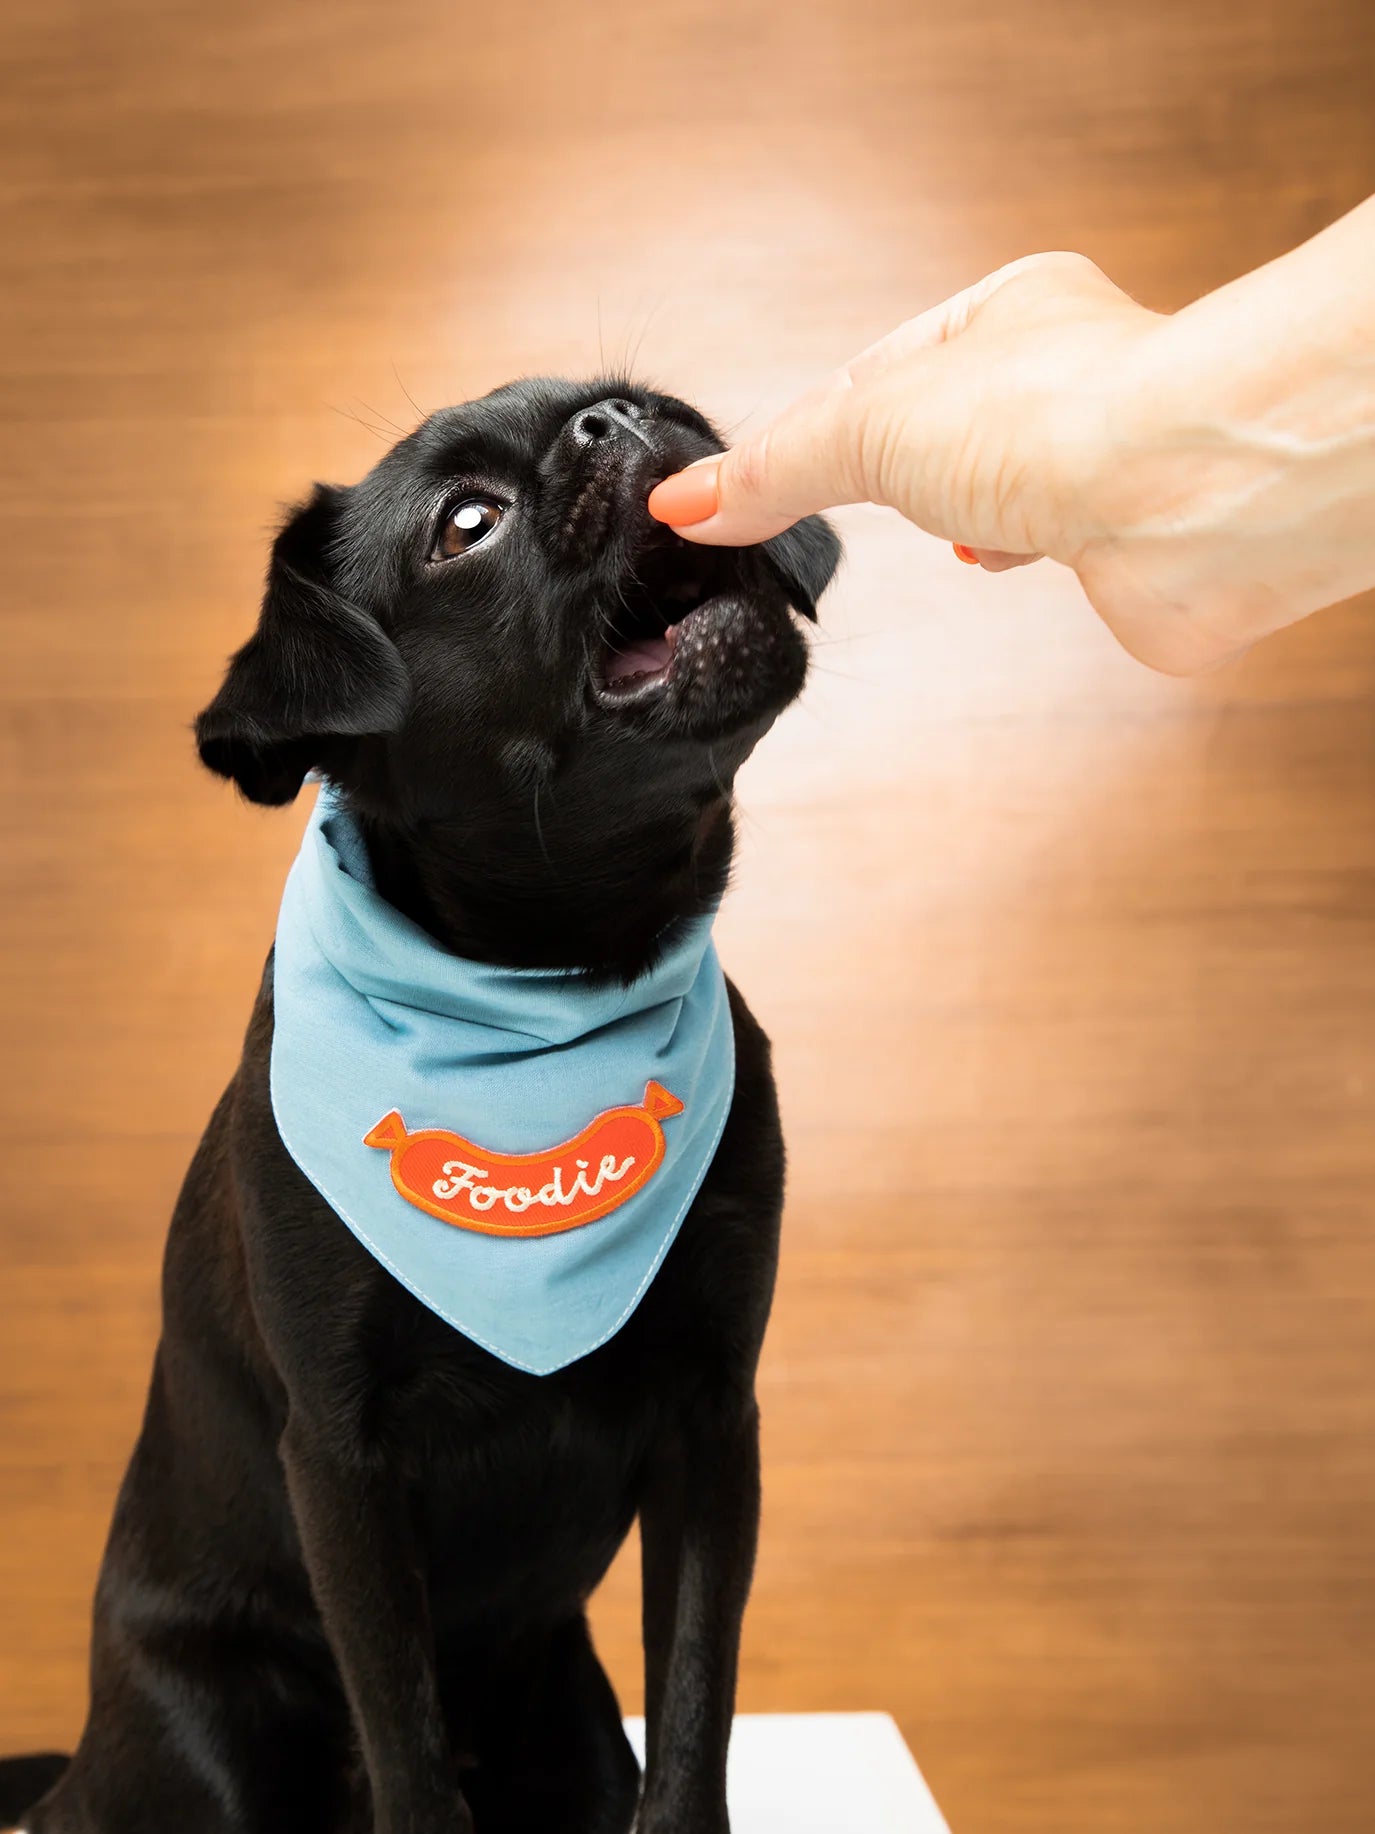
[596,536,735,702]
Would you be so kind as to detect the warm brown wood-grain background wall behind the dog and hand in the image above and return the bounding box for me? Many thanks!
[0,0,1375,1834]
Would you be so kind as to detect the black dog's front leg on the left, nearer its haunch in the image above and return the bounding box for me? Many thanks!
[281,1416,473,1834]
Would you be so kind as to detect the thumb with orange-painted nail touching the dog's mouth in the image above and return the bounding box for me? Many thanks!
[649,370,865,547]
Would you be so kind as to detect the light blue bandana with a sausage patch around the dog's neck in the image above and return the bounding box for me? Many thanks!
[271,789,735,1376]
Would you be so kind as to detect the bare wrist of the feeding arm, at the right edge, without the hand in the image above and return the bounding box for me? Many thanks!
[1071,232,1375,647]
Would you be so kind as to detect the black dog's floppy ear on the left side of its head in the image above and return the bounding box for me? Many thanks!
[196,484,411,803]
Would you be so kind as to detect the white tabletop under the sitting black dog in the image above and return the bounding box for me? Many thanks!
[625,1713,950,1834]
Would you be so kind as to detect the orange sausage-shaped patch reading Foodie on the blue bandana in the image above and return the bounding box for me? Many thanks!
[363,1082,682,1236]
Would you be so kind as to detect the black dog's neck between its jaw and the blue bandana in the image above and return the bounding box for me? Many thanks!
[361,796,733,981]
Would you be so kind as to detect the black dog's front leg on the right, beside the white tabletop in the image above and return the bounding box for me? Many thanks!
[640,1394,759,1834]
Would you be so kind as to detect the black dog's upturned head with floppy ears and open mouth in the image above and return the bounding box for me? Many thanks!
[196,380,840,968]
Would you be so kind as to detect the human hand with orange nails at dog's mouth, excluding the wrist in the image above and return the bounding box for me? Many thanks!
[649,255,1155,567]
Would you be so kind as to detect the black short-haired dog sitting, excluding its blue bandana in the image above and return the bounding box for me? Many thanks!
[0,381,840,1834]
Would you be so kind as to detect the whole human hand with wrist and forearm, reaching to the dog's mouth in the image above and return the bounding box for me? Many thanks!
[649,205,1375,673]
